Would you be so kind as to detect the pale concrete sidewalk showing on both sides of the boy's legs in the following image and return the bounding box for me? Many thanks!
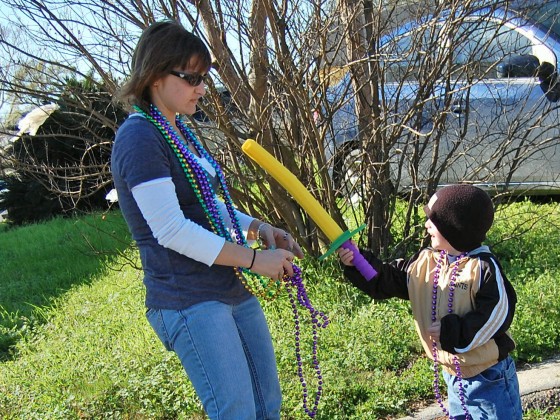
[399,356,560,420]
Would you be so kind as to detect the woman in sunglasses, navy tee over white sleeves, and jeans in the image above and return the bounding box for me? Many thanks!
[111,21,303,419]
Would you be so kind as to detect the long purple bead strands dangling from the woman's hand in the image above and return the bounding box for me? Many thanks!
[284,264,329,418]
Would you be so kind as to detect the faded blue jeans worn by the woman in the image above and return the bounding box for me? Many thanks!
[146,297,282,420]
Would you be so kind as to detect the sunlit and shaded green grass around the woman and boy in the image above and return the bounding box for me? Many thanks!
[0,202,560,419]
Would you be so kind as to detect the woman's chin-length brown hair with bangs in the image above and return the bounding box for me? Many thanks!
[115,20,212,111]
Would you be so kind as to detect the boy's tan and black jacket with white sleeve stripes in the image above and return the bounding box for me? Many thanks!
[344,246,517,378]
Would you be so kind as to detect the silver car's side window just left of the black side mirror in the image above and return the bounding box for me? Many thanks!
[448,19,533,80]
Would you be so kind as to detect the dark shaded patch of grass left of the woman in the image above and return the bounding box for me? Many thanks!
[0,210,132,361]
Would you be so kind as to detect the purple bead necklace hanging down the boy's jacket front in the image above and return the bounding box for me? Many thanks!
[432,251,472,420]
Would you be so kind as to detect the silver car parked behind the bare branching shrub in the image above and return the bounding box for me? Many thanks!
[326,0,560,195]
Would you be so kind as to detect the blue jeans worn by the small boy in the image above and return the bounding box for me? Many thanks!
[443,356,522,420]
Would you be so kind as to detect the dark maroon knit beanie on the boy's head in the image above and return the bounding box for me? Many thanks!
[424,184,494,251]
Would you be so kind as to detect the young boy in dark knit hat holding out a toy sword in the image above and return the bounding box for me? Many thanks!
[338,185,522,420]
